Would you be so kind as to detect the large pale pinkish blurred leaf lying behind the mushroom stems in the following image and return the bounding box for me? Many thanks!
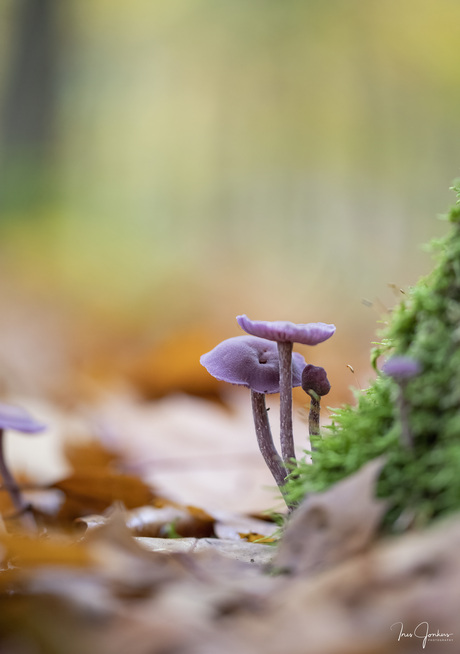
[88,387,290,516]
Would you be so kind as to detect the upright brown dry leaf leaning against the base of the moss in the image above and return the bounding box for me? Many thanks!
[275,457,387,574]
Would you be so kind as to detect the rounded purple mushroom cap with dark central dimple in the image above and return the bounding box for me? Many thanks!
[200,336,305,393]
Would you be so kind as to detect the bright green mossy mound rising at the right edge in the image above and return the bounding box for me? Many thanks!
[288,180,460,530]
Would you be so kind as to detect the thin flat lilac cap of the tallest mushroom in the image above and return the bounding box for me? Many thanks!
[236,315,335,345]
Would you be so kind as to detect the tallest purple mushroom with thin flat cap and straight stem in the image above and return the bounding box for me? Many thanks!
[236,315,335,464]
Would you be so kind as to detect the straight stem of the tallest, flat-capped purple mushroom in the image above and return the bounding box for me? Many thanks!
[278,341,296,465]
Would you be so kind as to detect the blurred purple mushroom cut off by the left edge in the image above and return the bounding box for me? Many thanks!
[0,403,46,529]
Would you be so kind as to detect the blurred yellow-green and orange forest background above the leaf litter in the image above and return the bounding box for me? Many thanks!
[0,0,460,510]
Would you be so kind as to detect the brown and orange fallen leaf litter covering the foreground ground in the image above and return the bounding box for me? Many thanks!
[0,434,460,654]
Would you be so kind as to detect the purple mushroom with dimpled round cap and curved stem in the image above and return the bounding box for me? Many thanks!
[200,336,305,500]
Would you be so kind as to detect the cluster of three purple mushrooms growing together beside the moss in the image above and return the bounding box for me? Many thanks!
[200,315,335,504]
